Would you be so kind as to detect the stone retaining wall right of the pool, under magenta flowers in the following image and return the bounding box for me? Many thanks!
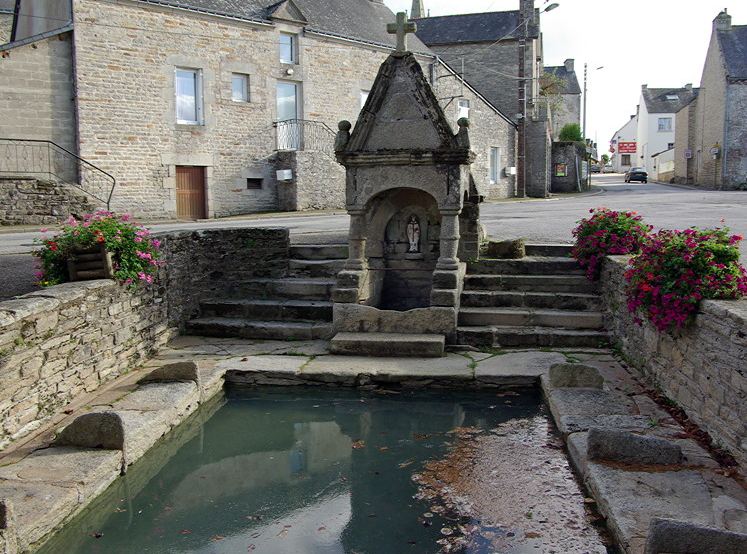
[601,257,747,466]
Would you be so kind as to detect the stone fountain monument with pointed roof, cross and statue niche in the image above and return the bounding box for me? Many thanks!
[331,14,480,356]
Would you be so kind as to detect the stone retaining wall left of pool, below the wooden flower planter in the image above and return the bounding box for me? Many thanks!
[0,229,289,449]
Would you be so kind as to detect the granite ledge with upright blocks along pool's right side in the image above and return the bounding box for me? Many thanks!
[540,364,747,554]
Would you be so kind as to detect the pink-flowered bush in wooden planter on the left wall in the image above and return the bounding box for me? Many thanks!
[34,211,164,288]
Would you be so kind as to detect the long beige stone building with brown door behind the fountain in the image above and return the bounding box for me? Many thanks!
[0,0,516,218]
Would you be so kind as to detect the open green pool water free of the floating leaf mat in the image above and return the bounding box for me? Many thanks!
[40,388,556,554]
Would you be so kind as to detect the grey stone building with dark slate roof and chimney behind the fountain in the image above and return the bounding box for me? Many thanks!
[413,0,556,197]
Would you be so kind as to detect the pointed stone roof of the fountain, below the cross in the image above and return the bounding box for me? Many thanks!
[339,54,465,157]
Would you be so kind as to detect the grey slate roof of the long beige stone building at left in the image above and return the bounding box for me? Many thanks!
[131,0,428,52]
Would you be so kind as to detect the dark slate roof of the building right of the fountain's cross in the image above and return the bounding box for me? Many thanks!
[415,10,537,46]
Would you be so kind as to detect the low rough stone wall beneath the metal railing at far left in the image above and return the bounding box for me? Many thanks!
[0,178,106,225]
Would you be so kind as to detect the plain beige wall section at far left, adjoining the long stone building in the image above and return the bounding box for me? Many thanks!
[0,32,76,152]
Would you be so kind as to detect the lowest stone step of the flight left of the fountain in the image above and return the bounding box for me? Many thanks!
[187,317,332,340]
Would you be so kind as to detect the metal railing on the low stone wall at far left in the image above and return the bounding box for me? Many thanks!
[0,138,117,210]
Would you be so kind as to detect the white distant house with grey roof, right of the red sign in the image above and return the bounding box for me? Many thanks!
[631,84,698,175]
